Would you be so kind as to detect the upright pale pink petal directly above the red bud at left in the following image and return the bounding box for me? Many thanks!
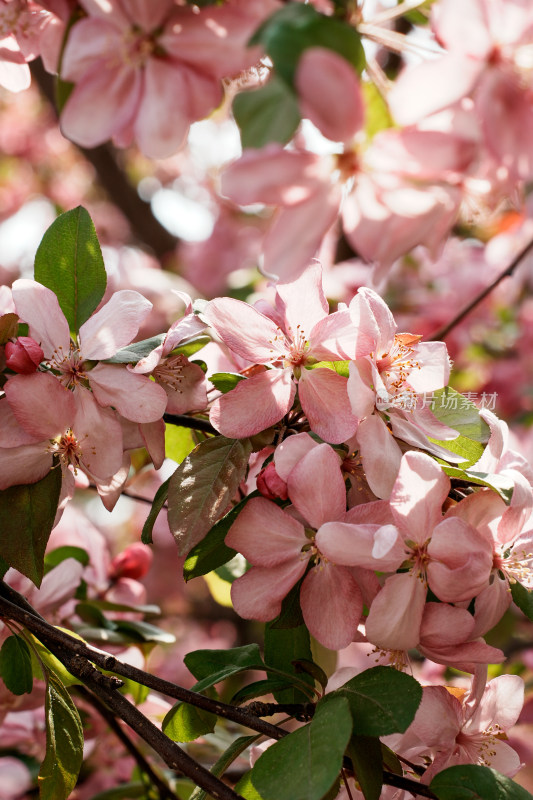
[12,278,70,358]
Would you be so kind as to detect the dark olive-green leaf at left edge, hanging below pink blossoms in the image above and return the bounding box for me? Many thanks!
[0,467,62,586]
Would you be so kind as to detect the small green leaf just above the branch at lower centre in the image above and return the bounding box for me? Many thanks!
[184,644,265,692]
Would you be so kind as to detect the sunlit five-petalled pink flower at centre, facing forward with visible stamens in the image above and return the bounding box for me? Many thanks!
[203,265,368,443]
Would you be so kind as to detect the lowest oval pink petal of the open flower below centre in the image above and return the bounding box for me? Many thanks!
[300,564,363,650]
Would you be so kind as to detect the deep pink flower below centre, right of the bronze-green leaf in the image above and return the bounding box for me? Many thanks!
[226,444,363,649]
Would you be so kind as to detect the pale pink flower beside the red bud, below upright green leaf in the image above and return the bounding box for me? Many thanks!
[12,279,167,424]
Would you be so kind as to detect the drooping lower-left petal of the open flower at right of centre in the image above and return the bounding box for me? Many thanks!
[366,572,426,650]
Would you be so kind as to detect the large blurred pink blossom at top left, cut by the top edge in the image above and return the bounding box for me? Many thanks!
[61,0,276,158]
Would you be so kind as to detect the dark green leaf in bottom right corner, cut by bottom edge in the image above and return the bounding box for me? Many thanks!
[429,764,533,800]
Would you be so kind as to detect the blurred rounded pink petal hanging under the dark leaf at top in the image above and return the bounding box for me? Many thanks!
[294,47,364,142]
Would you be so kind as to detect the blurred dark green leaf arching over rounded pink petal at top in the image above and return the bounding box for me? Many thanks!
[250,3,365,87]
